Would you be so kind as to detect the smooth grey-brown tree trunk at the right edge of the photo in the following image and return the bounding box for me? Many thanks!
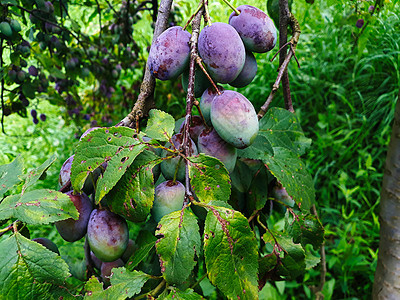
[372,93,400,300]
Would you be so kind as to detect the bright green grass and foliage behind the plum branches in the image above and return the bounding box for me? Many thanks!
[0,0,400,299]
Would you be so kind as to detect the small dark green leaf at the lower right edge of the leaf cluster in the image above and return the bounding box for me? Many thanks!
[286,215,324,250]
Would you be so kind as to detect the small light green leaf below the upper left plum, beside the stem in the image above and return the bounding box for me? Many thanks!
[145,109,175,142]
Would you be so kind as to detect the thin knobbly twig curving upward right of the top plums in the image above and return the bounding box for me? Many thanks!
[258,13,301,119]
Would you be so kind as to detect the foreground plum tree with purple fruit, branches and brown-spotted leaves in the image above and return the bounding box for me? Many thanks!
[0,0,324,299]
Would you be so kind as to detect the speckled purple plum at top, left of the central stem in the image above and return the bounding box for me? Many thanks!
[147,26,191,80]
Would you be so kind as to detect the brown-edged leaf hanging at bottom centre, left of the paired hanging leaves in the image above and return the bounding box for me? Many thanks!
[156,208,200,284]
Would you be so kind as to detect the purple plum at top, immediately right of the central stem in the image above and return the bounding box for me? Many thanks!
[198,22,246,83]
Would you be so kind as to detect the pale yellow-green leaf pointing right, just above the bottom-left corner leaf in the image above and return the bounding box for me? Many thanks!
[0,189,79,224]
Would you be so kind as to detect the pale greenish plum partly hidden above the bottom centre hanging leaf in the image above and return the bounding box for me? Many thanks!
[152,180,185,223]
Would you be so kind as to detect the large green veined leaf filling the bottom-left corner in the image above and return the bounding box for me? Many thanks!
[0,232,70,299]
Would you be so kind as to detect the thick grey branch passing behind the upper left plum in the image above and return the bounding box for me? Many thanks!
[116,0,172,128]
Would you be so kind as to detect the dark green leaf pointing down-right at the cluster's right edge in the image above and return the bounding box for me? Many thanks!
[263,148,315,211]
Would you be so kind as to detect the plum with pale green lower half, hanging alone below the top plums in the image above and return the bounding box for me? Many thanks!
[210,90,259,149]
